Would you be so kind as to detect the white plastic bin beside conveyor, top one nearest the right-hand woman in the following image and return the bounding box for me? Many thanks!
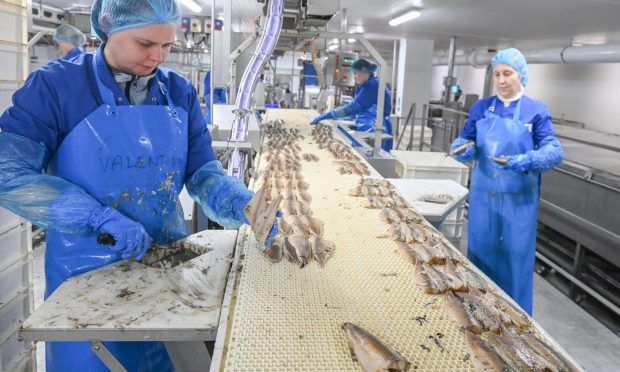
[391,150,469,187]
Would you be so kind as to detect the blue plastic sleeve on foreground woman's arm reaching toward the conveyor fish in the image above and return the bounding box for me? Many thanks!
[186,160,254,229]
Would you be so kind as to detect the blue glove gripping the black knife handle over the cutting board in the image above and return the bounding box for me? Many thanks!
[88,207,149,260]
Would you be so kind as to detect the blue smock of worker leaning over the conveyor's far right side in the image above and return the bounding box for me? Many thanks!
[332,75,393,151]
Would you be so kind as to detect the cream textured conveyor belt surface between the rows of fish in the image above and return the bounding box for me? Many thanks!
[216,110,580,371]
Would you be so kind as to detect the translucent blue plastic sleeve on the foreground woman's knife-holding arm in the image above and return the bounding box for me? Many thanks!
[0,133,101,234]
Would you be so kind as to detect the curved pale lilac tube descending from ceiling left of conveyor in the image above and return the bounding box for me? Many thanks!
[228,0,284,179]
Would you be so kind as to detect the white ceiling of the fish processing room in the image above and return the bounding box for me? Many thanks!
[33,0,620,51]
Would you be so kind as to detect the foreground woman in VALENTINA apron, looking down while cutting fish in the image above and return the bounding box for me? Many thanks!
[0,0,277,372]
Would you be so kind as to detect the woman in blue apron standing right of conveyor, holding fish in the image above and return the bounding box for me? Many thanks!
[451,48,564,315]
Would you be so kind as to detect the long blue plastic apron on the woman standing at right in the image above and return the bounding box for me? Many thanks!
[467,98,539,314]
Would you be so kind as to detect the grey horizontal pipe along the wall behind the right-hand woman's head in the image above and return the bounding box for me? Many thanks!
[433,44,620,68]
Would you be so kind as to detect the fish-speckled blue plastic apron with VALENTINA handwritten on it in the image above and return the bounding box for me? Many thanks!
[45,57,188,372]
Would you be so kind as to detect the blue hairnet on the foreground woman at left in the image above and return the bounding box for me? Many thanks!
[90,0,181,41]
